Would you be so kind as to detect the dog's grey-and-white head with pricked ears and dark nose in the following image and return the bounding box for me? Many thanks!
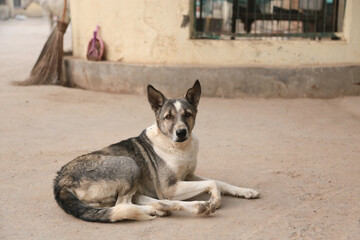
[147,80,201,142]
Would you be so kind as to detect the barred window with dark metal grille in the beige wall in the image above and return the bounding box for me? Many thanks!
[193,0,346,40]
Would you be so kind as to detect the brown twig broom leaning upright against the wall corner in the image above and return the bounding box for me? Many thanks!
[17,0,68,86]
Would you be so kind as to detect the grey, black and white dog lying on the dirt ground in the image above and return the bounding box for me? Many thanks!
[54,80,259,222]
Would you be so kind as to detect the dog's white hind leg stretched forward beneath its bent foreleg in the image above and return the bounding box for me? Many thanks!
[133,195,211,215]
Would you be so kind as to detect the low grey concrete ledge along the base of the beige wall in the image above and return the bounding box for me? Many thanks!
[64,57,360,98]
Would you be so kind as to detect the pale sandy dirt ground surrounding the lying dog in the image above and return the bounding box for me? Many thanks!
[0,19,360,240]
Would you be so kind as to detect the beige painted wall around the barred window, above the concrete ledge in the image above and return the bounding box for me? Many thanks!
[70,0,360,66]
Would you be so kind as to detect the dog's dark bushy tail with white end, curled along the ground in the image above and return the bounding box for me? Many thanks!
[54,182,154,222]
